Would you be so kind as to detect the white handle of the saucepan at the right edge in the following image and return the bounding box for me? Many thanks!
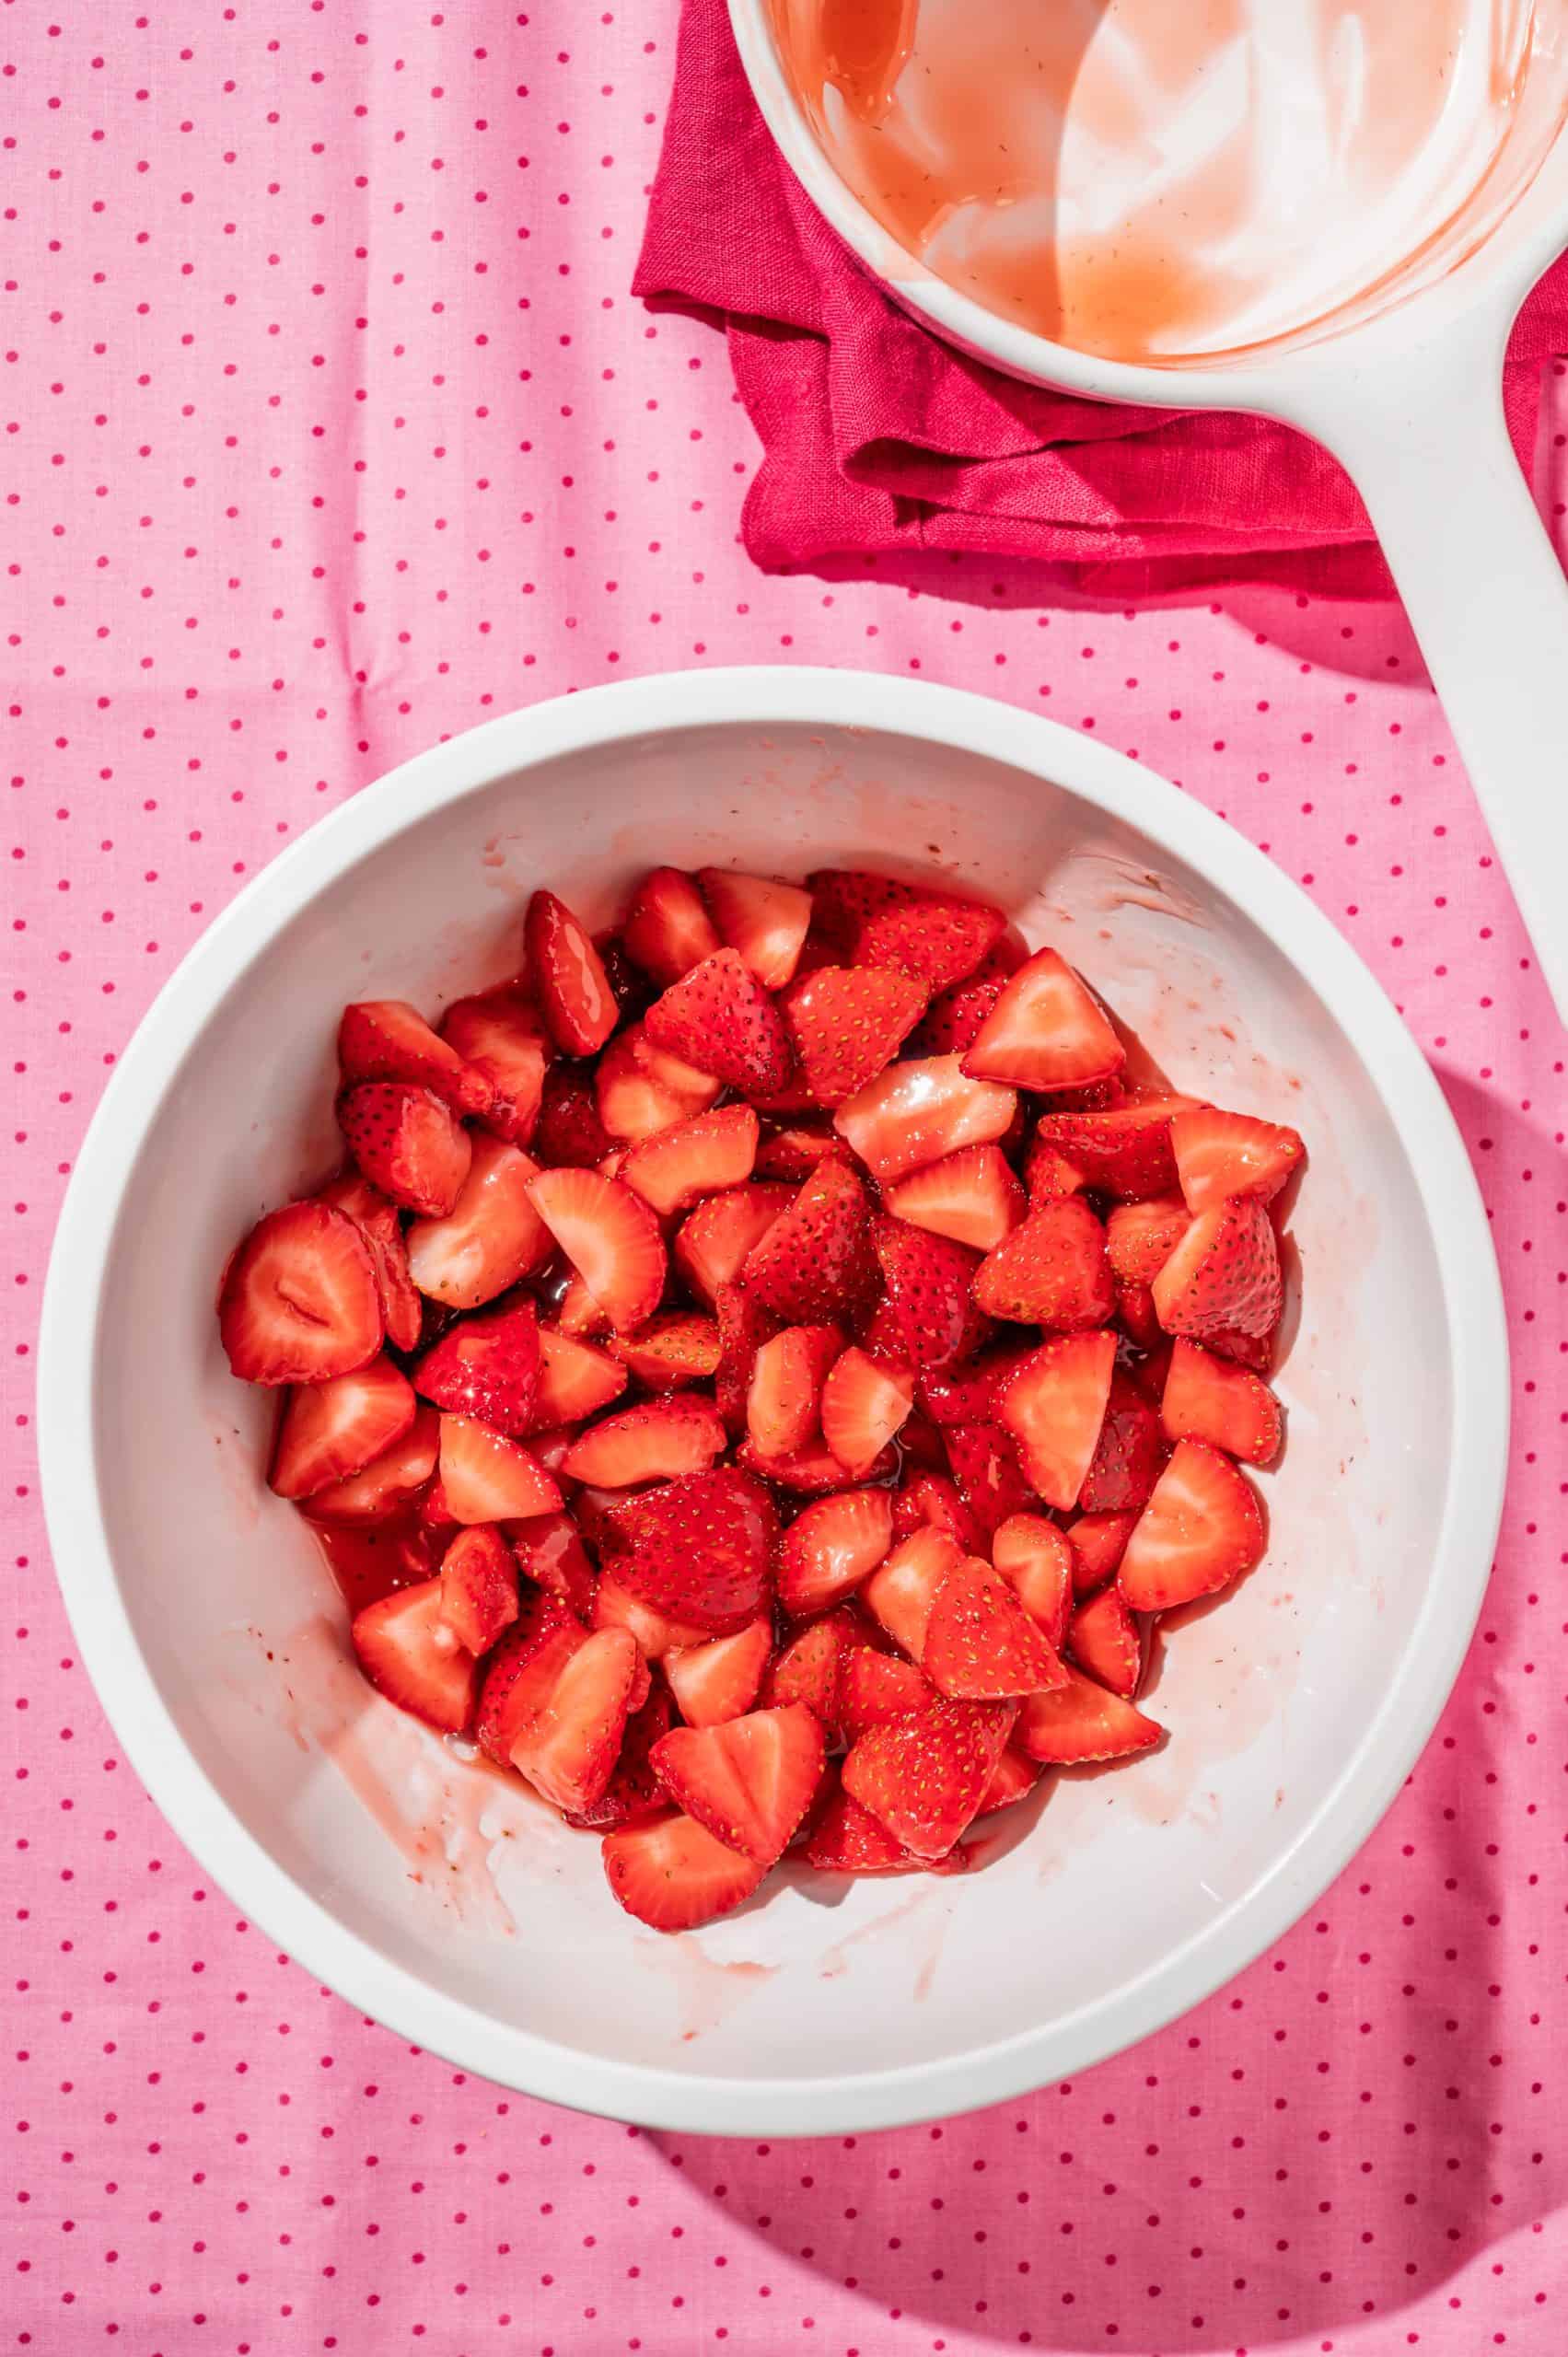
[1295,316,1568,1020]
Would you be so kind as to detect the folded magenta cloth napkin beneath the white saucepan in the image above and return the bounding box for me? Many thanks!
[636,0,1568,597]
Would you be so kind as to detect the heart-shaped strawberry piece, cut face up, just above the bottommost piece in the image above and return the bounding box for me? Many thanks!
[653,1701,823,1867]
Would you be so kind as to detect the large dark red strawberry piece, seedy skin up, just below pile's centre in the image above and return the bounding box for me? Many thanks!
[609,1466,778,1636]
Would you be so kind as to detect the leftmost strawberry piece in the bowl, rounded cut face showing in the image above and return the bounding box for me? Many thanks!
[217,1197,384,1384]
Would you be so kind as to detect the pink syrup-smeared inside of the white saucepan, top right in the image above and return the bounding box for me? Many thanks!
[771,0,1565,366]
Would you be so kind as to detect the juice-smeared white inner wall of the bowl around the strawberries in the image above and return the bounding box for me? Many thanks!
[94,721,1455,2126]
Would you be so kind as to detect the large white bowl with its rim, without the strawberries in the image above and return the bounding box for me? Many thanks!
[41,669,1509,2135]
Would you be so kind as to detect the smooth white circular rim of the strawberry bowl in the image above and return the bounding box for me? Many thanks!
[38,665,1509,2135]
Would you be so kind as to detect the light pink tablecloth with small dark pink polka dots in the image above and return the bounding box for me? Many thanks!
[0,0,1568,2357]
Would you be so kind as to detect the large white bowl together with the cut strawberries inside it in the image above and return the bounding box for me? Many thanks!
[41,669,1506,2133]
